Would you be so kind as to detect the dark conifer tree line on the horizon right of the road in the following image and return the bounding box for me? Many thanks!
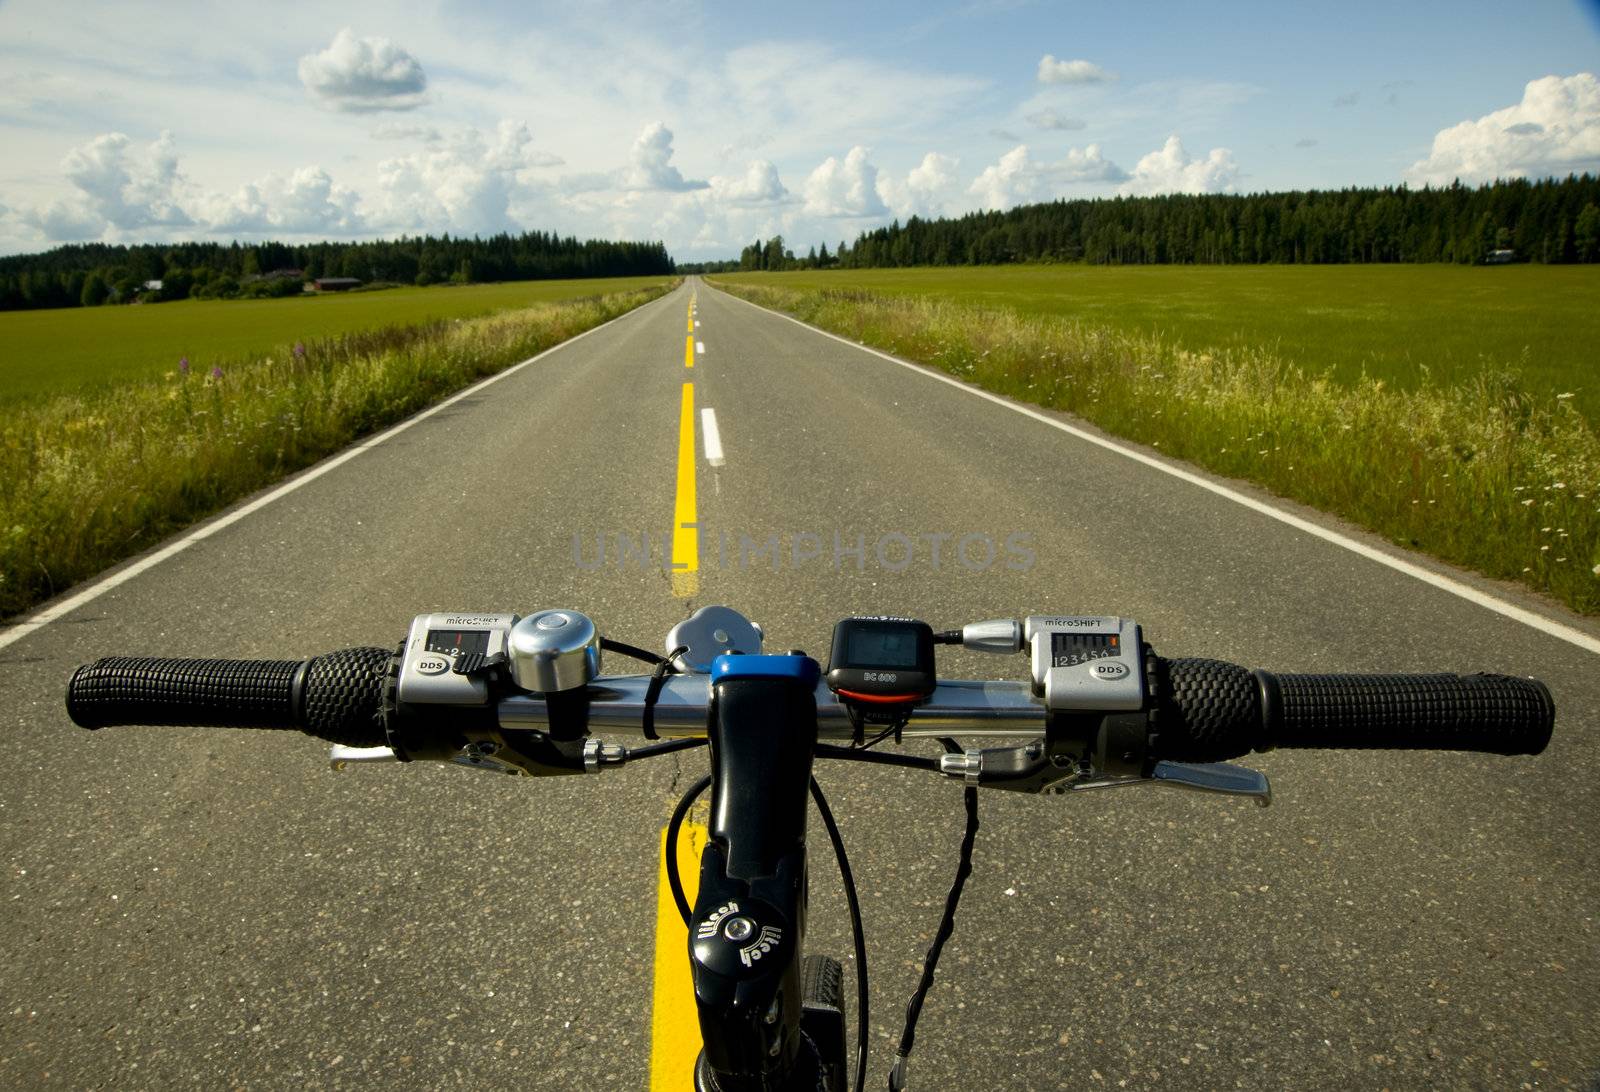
[707,175,1600,272]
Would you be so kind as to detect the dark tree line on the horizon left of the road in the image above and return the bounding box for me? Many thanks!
[0,231,674,311]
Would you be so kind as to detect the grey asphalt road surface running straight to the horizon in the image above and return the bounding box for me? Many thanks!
[0,282,1600,1089]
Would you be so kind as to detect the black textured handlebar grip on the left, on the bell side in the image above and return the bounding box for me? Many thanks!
[67,648,394,746]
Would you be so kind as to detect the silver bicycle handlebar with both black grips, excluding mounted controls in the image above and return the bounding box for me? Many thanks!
[67,648,1555,762]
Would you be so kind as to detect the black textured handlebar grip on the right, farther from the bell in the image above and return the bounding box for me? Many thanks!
[1150,656,1555,762]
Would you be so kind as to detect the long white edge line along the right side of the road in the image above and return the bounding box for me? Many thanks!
[717,288,1600,655]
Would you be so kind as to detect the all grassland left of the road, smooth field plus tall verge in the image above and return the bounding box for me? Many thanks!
[0,277,675,616]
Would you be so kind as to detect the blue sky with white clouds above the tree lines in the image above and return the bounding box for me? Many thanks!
[0,0,1600,261]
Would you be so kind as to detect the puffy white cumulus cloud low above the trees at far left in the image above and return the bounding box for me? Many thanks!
[22,131,194,240]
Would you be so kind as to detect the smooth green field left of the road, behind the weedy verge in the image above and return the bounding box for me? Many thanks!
[0,277,669,405]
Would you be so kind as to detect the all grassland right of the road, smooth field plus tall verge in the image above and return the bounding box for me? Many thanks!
[712,267,1600,615]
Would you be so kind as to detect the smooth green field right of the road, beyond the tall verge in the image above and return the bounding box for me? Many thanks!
[717,264,1600,421]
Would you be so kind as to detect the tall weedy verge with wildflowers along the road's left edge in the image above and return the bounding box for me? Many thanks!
[0,280,672,615]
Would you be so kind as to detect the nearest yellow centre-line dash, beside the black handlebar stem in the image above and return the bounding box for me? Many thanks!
[650,823,707,1092]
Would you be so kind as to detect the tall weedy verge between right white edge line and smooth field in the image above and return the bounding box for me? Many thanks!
[714,271,1600,615]
